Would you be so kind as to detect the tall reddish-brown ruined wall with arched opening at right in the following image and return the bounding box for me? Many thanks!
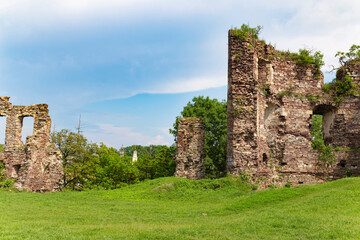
[227,30,360,187]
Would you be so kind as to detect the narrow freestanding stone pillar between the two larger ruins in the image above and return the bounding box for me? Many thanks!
[175,118,205,179]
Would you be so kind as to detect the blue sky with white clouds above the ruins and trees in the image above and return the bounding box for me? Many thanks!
[0,0,360,148]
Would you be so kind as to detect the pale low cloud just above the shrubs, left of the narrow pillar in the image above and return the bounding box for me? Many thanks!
[84,124,170,148]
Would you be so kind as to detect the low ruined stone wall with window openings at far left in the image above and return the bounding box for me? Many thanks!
[0,97,64,192]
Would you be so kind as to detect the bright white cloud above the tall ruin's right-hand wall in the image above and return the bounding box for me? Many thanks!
[266,0,360,71]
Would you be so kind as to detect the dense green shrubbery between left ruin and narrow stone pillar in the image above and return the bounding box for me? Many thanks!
[51,129,175,190]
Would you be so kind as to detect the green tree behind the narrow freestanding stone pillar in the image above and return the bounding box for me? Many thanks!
[170,96,227,178]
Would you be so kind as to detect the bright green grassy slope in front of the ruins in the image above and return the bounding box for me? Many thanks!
[0,178,360,239]
